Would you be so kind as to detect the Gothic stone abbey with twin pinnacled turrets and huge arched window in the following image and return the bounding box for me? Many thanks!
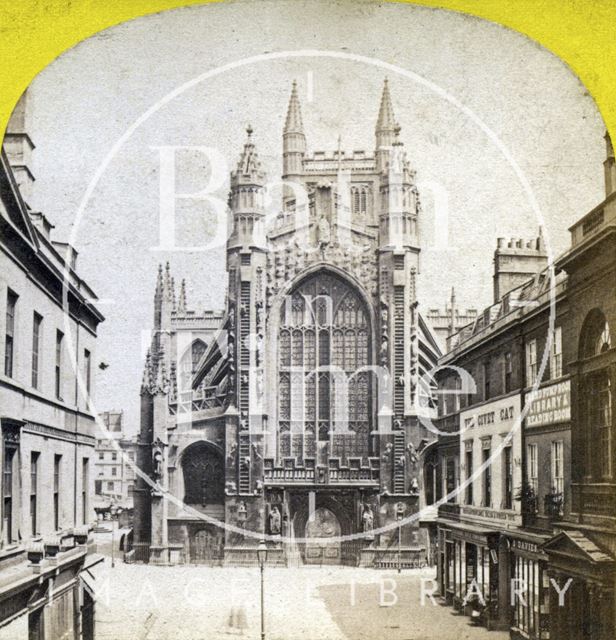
[134,81,439,566]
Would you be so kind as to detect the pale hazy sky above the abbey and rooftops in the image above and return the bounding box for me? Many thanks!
[20,0,605,433]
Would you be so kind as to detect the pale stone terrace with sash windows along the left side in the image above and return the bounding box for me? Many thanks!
[0,95,103,640]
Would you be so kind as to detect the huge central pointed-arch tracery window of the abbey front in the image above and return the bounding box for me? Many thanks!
[278,272,370,462]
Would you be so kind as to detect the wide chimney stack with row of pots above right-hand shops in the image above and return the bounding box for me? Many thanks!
[493,229,548,303]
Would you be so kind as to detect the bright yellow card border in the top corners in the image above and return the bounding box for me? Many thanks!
[0,0,616,132]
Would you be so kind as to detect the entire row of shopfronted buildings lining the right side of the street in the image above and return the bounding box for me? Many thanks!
[424,140,616,640]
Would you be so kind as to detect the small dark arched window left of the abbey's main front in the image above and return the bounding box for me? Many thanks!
[182,442,225,507]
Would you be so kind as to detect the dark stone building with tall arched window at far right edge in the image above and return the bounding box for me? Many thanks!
[544,137,616,640]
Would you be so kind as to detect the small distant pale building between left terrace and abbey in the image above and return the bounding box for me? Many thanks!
[94,411,138,514]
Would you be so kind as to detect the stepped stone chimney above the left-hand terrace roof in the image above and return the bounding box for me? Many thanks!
[4,89,35,204]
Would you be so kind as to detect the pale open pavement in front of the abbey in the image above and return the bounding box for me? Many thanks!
[89,558,509,640]
